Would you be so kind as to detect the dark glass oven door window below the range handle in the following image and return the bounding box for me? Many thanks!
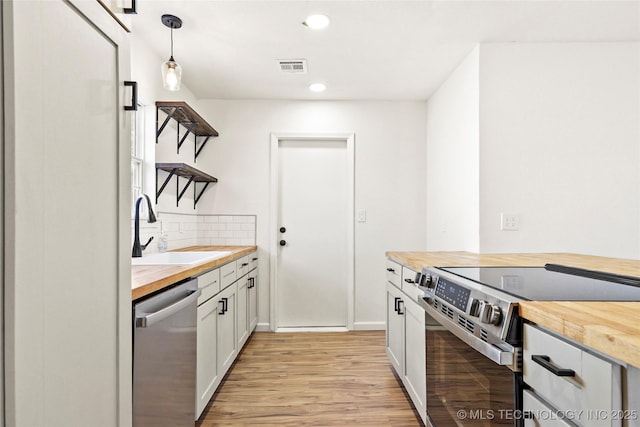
[426,318,520,427]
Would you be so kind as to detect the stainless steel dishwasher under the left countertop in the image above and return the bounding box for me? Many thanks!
[133,279,200,427]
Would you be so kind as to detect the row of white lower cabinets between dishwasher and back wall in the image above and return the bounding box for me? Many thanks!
[195,253,258,420]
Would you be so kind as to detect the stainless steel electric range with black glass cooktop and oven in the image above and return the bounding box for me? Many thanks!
[417,264,640,427]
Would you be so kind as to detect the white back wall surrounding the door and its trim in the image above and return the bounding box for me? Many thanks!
[198,100,426,328]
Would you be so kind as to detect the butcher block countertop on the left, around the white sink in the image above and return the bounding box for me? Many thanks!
[131,246,258,300]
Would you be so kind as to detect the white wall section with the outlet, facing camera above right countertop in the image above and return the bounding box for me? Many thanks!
[480,43,640,258]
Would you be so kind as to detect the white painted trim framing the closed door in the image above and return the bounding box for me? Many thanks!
[269,133,356,331]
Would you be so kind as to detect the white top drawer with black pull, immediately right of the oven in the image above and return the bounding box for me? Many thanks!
[523,324,622,426]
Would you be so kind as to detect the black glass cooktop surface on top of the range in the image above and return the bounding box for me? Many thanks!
[440,264,640,301]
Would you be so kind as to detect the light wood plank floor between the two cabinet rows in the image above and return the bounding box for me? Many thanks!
[196,331,421,427]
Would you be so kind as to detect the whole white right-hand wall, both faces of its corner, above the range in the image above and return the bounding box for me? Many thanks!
[427,43,640,258]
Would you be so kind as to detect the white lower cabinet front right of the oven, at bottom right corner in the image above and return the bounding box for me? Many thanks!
[522,324,624,427]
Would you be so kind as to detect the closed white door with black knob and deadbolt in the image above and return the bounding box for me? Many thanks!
[274,138,353,328]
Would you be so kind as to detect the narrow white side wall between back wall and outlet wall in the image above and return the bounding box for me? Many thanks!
[426,48,480,252]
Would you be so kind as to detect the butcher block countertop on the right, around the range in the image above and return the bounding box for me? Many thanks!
[386,252,640,367]
